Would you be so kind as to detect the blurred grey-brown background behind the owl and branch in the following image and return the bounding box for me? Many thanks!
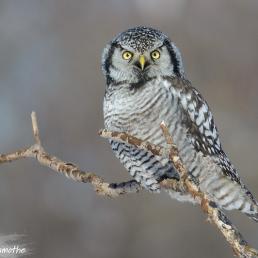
[0,0,258,258]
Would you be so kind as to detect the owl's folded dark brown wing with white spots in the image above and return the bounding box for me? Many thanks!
[166,78,242,184]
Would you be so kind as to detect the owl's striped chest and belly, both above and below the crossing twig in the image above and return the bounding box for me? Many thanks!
[104,78,199,194]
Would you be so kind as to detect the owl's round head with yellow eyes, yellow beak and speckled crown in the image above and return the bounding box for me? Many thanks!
[102,27,184,87]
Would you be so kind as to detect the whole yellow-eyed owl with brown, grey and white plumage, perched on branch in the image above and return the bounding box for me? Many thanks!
[102,27,258,221]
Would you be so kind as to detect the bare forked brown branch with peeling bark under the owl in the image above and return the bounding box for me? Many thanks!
[0,112,258,258]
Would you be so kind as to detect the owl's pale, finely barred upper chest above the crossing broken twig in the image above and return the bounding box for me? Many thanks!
[104,78,186,145]
